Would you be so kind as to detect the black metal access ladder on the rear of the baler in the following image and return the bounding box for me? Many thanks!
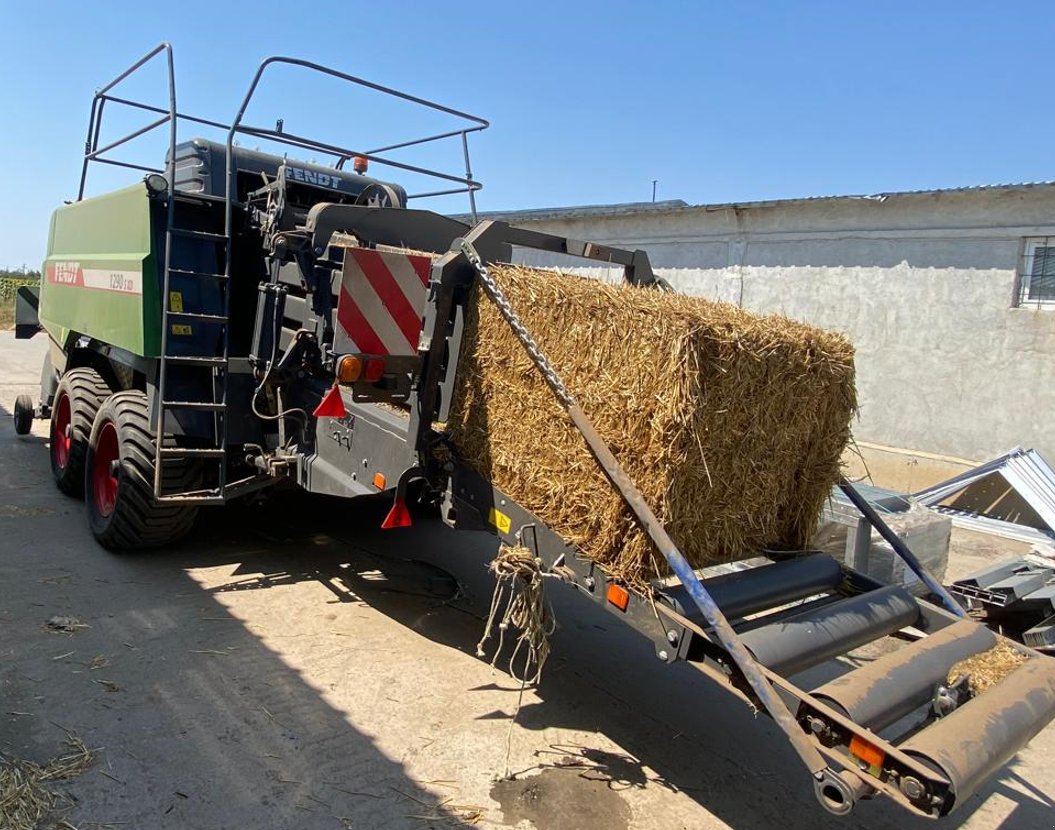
[154,190,231,504]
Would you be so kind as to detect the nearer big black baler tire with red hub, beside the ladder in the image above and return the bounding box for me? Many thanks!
[84,390,200,551]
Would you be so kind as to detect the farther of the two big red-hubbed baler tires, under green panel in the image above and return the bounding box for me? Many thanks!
[50,366,110,498]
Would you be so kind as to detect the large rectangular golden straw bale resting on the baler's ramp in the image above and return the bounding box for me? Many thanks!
[448,266,856,584]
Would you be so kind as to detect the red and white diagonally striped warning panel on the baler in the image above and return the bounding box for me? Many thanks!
[333,248,433,354]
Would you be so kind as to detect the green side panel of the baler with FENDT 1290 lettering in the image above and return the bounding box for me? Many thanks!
[40,184,160,358]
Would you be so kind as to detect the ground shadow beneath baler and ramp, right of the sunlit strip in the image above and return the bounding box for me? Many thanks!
[168,494,1055,830]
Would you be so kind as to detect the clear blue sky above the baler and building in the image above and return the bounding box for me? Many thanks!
[0,0,1055,266]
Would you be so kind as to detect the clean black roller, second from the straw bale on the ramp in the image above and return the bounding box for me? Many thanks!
[741,585,919,675]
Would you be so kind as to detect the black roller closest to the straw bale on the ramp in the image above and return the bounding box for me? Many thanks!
[664,554,843,618]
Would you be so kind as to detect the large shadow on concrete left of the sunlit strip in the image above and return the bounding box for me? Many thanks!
[0,428,471,830]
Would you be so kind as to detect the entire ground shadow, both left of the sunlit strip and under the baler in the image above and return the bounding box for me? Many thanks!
[0,394,1055,830]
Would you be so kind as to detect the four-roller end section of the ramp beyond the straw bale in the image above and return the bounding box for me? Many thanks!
[641,554,1055,816]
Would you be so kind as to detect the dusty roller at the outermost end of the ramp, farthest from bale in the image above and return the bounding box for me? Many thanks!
[899,657,1055,810]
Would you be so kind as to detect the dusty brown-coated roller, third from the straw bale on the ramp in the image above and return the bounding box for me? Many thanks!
[811,620,996,732]
